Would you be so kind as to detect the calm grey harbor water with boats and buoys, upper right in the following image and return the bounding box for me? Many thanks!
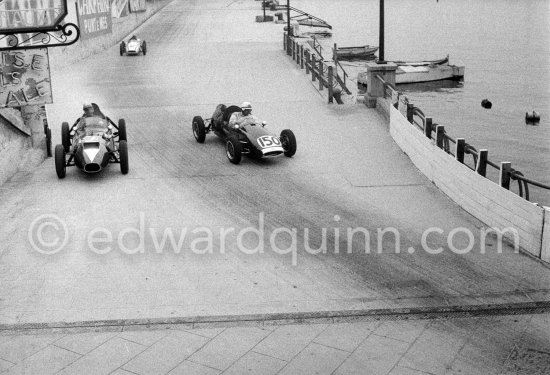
[292,0,550,205]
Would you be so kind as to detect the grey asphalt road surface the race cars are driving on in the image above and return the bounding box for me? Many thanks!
[0,0,550,323]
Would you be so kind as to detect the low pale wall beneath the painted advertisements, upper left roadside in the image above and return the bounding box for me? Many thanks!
[49,0,173,68]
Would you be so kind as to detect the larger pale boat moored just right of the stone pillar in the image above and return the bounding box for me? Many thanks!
[392,55,464,84]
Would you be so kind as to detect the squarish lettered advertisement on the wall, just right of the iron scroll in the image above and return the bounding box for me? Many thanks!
[77,0,112,40]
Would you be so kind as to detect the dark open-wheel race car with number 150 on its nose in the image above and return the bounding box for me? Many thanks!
[192,104,296,164]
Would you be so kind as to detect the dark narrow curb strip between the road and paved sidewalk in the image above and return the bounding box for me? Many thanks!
[0,301,550,333]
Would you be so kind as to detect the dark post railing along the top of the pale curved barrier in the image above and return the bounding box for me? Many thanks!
[376,75,550,200]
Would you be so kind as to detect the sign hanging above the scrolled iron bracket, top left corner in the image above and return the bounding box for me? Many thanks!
[0,0,67,33]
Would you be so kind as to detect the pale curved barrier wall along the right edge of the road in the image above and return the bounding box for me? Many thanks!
[388,101,550,261]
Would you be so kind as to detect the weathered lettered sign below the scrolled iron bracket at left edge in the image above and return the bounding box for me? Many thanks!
[0,48,53,107]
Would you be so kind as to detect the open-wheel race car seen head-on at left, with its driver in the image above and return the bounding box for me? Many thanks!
[54,103,129,178]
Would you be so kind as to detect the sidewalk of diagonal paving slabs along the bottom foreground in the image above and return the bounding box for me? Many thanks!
[0,313,550,375]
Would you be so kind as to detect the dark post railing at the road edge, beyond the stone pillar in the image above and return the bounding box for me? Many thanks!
[283,33,349,104]
